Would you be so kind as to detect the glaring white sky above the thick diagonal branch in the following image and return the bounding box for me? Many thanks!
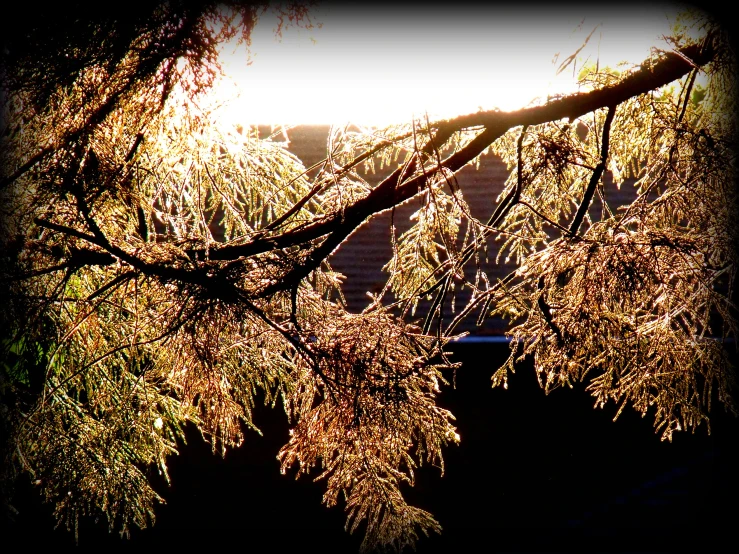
[211,2,692,125]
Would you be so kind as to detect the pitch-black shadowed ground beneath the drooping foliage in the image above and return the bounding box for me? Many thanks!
[3,343,739,554]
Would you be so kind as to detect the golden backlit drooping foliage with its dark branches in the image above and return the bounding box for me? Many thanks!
[0,2,737,549]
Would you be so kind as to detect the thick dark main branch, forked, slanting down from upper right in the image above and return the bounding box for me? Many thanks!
[28,35,716,302]
